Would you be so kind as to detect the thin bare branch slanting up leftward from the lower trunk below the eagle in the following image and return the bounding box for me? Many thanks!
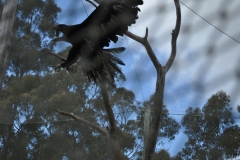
[55,109,108,136]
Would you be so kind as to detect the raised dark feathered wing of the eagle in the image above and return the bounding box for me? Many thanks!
[82,0,143,48]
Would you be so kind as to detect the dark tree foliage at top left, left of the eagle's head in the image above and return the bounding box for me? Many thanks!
[8,0,61,77]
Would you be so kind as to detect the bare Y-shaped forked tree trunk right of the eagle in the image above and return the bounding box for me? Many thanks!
[126,0,181,160]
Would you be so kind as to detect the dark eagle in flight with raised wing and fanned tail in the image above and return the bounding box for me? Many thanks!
[52,0,143,83]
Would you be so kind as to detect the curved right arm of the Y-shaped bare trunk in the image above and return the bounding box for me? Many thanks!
[165,0,181,72]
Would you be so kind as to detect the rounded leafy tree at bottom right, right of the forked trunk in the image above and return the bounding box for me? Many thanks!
[178,91,237,159]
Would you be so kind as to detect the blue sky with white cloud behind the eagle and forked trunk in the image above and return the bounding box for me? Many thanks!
[53,0,240,155]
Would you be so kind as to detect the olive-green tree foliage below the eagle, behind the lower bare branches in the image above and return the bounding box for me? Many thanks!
[0,65,180,160]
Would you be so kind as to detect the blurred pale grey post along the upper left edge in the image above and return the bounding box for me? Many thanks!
[0,0,18,88]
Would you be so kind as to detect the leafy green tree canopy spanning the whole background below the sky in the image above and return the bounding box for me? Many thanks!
[0,0,240,160]
